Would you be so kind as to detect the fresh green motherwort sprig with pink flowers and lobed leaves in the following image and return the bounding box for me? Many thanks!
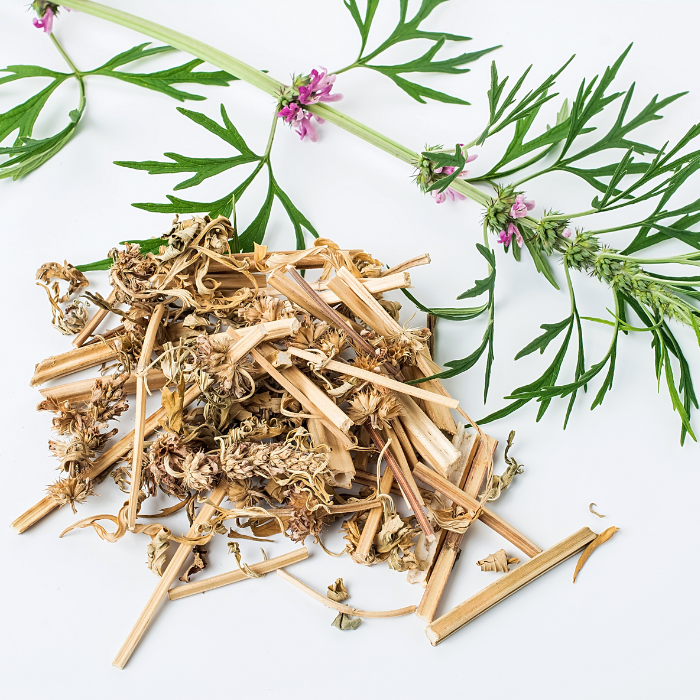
[0,0,700,442]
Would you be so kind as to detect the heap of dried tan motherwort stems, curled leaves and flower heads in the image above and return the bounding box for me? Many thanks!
[13,217,616,667]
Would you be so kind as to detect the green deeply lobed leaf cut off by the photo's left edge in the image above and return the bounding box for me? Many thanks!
[0,43,235,180]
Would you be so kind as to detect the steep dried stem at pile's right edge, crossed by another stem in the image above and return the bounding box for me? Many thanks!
[416,434,498,622]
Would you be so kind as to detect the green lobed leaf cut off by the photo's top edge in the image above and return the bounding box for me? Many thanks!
[339,0,500,105]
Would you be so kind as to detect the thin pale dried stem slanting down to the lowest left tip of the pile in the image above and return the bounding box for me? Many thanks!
[112,479,228,668]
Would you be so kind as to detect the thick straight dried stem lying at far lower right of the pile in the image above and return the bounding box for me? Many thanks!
[425,527,596,646]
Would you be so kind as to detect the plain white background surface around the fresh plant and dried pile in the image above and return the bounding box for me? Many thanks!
[0,0,700,700]
